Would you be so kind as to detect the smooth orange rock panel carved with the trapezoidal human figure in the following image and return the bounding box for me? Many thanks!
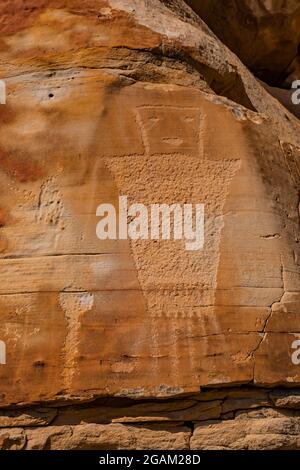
[0,71,296,405]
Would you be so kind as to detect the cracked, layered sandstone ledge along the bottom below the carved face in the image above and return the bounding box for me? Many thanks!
[0,387,300,450]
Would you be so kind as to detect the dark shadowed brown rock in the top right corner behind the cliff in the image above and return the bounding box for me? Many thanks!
[186,0,300,86]
